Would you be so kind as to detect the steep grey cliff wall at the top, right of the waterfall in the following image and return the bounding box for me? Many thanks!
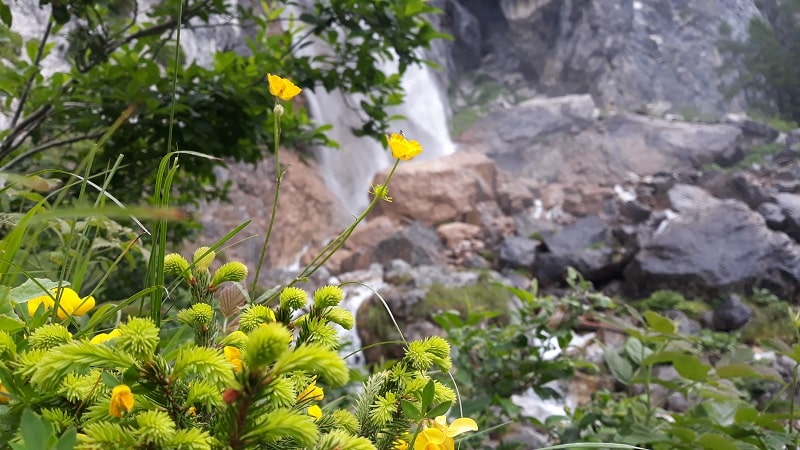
[445,0,760,113]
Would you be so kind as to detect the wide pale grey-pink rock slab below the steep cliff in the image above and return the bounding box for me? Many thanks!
[461,95,742,185]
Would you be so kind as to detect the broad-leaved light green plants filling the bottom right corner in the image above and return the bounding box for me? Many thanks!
[547,312,800,450]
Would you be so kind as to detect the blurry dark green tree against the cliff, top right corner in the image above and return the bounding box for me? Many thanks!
[719,0,800,123]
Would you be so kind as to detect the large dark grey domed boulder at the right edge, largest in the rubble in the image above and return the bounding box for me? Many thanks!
[624,200,800,299]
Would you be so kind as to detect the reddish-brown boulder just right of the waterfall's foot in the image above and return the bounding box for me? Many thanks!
[373,152,498,227]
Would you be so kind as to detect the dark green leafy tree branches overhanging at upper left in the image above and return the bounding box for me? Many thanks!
[0,0,445,213]
